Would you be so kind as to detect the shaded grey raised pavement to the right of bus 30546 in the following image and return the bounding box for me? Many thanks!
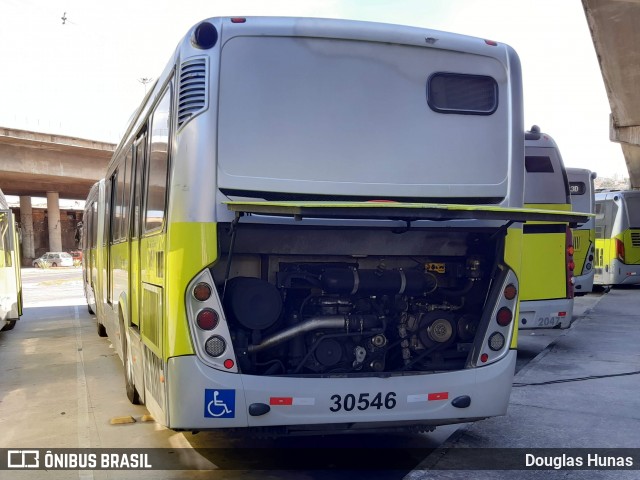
[405,287,640,480]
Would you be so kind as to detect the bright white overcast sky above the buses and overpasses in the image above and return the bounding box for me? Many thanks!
[0,0,627,177]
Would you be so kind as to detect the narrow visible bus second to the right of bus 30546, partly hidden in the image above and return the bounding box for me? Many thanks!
[567,168,597,295]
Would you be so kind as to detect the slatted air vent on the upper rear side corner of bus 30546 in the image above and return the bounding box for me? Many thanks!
[178,57,207,128]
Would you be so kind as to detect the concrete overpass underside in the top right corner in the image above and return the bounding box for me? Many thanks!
[582,0,640,188]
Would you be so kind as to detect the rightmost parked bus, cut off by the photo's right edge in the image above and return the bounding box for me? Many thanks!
[594,190,640,286]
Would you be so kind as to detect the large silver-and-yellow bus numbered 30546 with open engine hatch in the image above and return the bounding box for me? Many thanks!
[85,17,582,434]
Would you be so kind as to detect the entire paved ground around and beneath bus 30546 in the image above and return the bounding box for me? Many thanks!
[0,269,640,480]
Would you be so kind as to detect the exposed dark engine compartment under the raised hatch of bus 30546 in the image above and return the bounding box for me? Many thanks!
[212,224,504,376]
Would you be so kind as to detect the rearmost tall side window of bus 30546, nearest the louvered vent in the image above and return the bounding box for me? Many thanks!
[144,87,171,232]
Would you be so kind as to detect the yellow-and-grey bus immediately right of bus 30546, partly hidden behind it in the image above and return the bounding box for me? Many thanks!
[518,125,574,329]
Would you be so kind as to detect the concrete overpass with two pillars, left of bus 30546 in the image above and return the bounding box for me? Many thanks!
[0,127,115,259]
